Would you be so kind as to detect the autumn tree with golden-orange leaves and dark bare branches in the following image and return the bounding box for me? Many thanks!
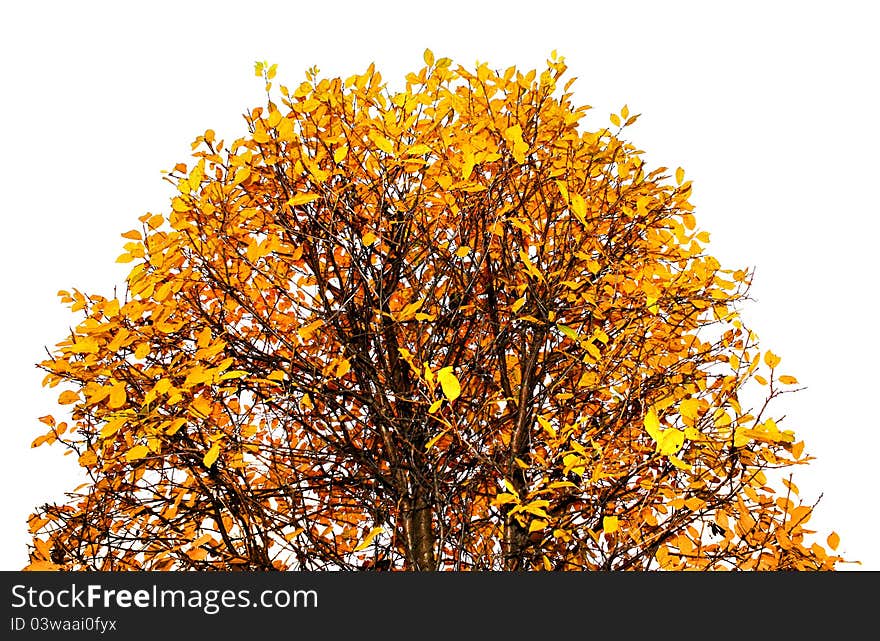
[24,51,841,570]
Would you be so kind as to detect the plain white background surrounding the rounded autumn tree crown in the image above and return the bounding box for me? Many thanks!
[0,0,880,570]
